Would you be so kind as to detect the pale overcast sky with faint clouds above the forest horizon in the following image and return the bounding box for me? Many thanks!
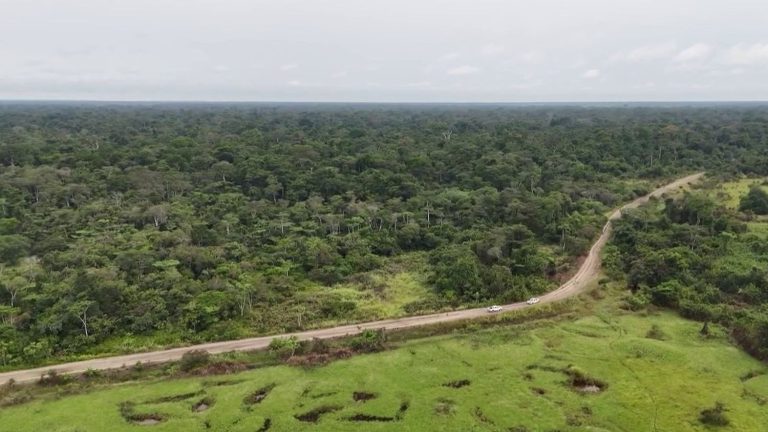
[0,0,768,102]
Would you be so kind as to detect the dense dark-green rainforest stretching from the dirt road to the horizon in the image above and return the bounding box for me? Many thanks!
[0,103,768,367]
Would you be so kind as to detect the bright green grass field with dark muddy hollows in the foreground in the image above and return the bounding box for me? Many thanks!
[0,290,768,432]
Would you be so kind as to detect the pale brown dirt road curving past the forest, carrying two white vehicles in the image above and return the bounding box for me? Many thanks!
[0,173,703,384]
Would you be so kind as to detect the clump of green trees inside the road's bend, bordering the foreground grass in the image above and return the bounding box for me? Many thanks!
[605,187,768,360]
